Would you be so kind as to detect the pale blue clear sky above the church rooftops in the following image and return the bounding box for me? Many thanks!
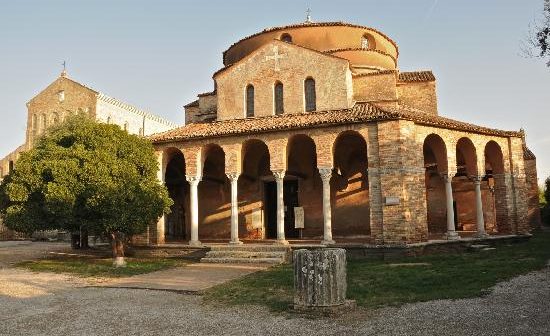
[0,0,550,179]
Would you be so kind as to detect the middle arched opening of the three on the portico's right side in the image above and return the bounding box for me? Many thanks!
[452,138,478,232]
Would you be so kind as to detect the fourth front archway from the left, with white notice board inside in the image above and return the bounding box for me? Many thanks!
[278,134,323,238]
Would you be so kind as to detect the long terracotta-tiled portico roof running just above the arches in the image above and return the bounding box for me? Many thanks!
[149,103,521,143]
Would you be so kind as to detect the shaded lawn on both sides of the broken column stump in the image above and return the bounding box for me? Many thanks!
[205,232,550,311]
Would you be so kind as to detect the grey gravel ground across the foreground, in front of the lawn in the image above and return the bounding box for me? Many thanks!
[0,267,550,336]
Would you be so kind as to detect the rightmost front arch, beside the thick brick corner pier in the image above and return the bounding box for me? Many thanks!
[330,131,371,236]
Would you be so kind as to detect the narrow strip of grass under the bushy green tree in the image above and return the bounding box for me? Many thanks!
[16,257,188,278]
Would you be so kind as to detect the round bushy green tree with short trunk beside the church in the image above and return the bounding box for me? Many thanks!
[0,115,172,266]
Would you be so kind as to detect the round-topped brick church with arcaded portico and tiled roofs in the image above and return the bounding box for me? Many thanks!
[148,20,538,246]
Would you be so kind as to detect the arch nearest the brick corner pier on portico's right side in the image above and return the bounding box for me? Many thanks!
[422,134,448,238]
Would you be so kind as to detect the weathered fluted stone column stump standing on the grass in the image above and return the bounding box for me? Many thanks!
[294,248,353,311]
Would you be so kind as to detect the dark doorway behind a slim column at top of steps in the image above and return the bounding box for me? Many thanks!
[264,180,299,239]
